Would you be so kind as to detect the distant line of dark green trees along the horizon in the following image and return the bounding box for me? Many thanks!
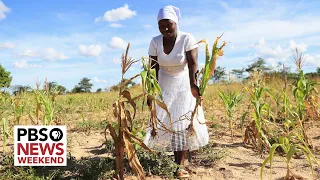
[0,58,320,95]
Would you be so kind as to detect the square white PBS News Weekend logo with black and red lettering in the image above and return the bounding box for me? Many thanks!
[14,126,67,166]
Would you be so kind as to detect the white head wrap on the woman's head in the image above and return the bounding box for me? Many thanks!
[158,6,181,24]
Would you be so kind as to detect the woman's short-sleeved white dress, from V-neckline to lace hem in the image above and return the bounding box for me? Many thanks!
[144,31,209,151]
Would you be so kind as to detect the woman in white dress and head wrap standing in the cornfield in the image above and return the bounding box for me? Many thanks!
[144,6,209,177]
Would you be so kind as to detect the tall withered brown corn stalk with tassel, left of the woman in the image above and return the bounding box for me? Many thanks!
[106,44,153,180]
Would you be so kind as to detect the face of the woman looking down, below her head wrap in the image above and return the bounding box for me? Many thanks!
[158,19,177,38]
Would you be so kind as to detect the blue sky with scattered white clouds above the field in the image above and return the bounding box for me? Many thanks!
[0,0,320,90]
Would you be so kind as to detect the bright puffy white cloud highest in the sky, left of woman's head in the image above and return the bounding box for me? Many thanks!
[95,4,137,22]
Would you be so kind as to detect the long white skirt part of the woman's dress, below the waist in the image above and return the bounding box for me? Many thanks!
[144,69,209,151]
